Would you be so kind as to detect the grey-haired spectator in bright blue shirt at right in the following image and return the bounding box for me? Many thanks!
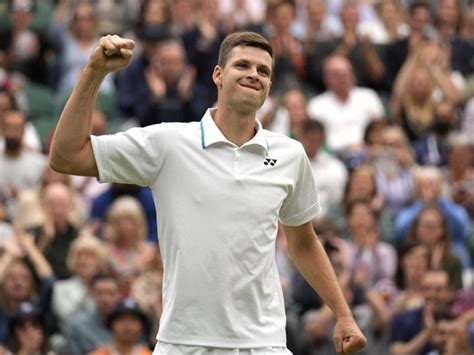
[395,166,471,268]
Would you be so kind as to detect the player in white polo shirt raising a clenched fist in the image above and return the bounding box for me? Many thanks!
[50,32,366,355]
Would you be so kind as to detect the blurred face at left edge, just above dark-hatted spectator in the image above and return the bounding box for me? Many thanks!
[3,261,33,302]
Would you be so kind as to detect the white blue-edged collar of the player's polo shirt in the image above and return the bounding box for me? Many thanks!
[200,108,270,152]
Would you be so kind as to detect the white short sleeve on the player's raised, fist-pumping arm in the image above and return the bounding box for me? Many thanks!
[91,124,168,186]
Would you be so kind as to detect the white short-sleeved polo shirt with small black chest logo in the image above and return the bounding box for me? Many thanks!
[92,110,320,348]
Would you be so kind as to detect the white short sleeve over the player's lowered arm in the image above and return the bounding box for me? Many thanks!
[280,145,321,226]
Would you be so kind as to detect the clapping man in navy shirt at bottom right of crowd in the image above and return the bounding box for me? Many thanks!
[390,270,462,354]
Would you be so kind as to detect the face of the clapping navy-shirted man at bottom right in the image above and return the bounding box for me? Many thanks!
[422,270,453,315]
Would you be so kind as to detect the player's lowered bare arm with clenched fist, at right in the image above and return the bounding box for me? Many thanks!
[283,222,367,354]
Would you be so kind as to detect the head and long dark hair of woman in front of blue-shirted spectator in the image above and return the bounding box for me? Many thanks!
[408,207,463,289]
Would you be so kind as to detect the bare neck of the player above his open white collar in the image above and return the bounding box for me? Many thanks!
[212,107,256,147]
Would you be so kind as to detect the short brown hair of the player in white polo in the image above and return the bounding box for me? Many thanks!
[217,32,273,68]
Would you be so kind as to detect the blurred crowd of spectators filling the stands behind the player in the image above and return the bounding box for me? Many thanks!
[0,0,474,355]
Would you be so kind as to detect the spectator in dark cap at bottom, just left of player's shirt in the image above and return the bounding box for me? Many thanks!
[88,298,151,355]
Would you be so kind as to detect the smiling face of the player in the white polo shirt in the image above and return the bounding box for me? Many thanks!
[212,46,272,114]
